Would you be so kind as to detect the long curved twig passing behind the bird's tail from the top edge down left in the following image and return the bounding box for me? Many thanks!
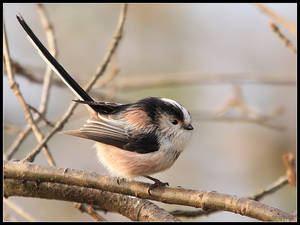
[25,4,127,162]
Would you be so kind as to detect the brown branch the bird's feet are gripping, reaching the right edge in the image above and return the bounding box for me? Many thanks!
[4,162,296,221]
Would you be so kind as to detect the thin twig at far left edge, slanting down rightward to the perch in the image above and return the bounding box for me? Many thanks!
[3,18,55,165]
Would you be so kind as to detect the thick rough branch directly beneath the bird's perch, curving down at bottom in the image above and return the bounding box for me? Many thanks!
[4,179,179,221]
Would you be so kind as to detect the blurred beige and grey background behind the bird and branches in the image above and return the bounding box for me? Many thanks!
[3,3,297,221]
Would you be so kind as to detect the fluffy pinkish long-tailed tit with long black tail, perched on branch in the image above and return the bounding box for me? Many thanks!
[17,16,193,194]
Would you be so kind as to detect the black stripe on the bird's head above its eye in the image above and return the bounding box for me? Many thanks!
[136,97,184,124]
